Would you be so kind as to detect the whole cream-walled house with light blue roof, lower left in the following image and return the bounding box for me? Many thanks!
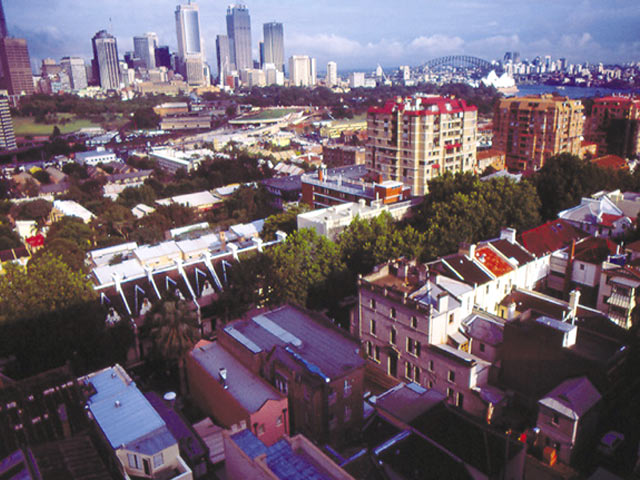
[80,365,193,480]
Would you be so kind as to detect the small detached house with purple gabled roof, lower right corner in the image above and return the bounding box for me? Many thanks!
[536,377,602,464]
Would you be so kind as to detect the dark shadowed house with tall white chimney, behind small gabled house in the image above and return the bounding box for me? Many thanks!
[499,290,628,408]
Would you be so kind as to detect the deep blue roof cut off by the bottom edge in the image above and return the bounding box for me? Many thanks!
[231,430,331,480]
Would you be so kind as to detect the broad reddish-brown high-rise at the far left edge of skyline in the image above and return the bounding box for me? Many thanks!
[0,37,34,95]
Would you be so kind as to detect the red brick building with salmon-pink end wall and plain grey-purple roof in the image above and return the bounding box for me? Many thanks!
[186,340,289,445]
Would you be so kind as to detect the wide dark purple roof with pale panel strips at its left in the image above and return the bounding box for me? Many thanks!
[224,305,365,382]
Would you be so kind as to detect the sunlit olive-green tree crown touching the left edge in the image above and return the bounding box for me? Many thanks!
[0,254,96,323]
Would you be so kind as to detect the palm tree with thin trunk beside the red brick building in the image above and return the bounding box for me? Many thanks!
[151,299,200,393]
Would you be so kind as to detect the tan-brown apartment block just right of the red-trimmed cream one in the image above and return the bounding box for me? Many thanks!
[493,94,584,171]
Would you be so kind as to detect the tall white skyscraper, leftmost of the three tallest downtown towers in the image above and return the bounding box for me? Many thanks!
[176,3,204,86]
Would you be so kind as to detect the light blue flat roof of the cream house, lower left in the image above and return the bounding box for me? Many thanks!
[85,365,176,455]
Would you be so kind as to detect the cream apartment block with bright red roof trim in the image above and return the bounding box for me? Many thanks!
[366,95,478,195]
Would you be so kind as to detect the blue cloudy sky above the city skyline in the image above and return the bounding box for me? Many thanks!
[2,0,640,71]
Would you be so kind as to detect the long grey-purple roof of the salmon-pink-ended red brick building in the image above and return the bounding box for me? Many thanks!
[190,342,283,413]
